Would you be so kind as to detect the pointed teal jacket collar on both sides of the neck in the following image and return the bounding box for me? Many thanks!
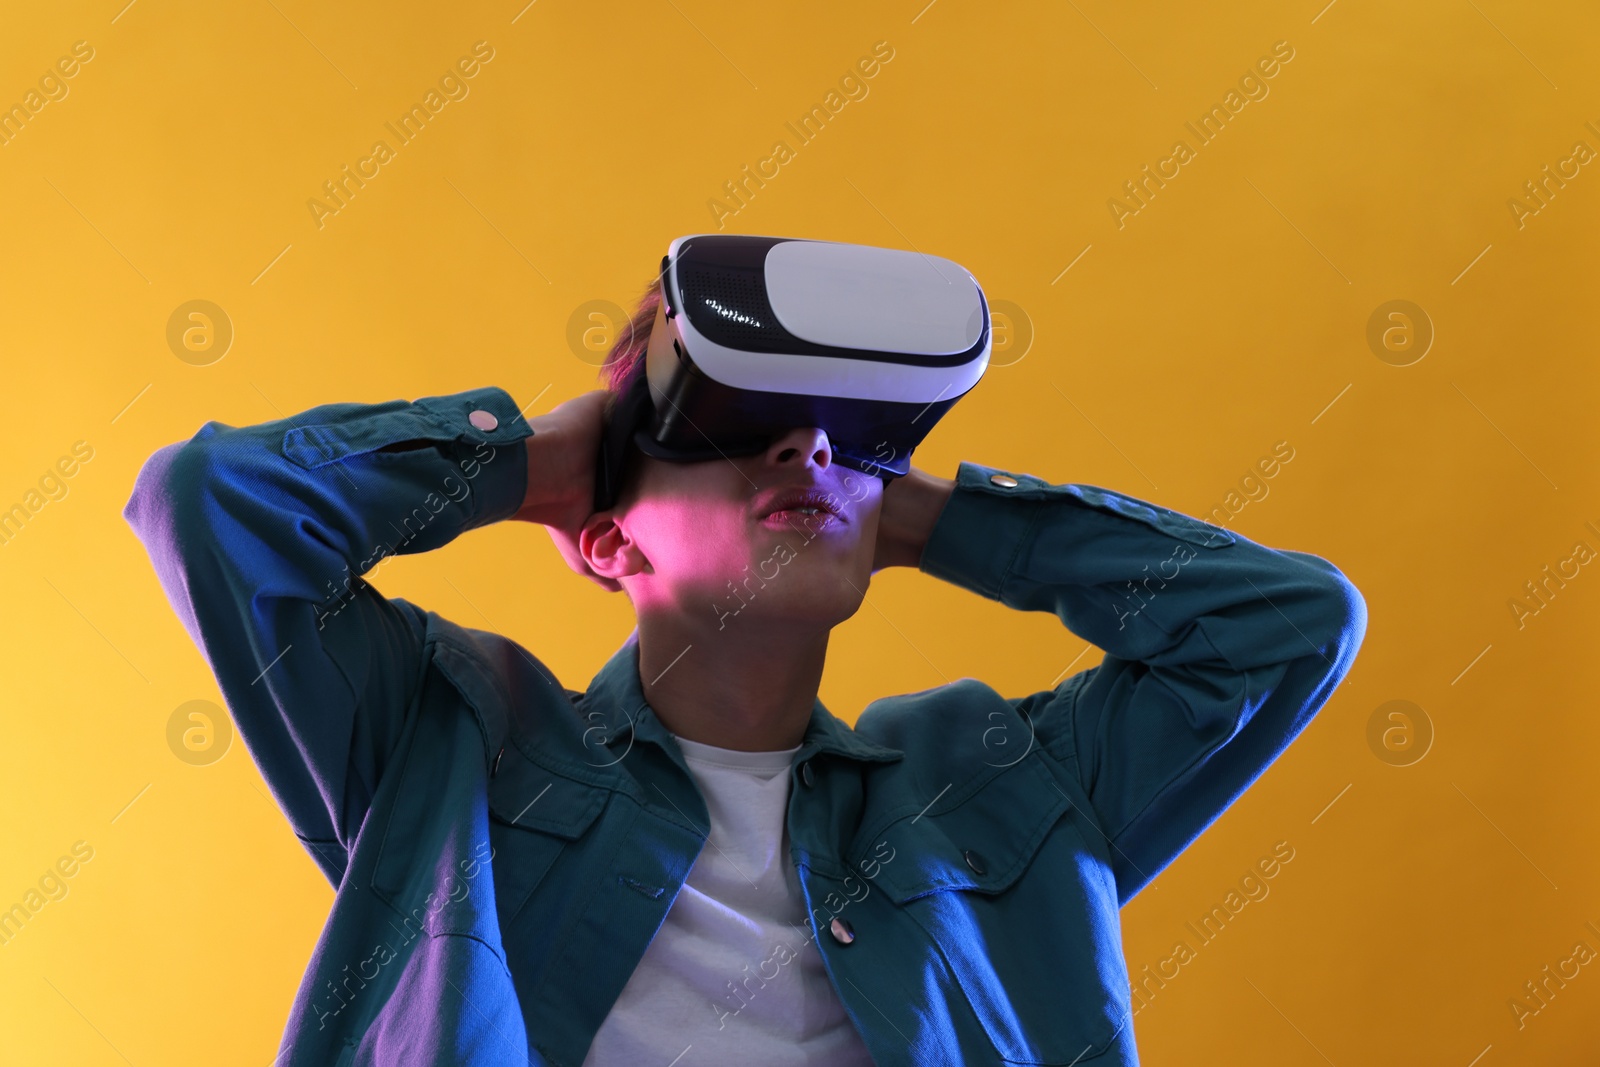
[582,627,906,765]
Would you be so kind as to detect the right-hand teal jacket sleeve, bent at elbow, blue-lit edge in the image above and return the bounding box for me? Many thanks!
[920,462,1366,904]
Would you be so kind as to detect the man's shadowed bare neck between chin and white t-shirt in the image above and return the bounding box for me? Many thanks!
[638,614,830,752]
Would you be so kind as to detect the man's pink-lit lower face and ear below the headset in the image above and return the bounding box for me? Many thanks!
[613,427,883,629]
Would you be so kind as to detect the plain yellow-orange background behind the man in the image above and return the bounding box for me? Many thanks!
[0,0,1600,1067]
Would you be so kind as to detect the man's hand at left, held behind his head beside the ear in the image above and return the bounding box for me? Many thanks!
[512,389,619,589]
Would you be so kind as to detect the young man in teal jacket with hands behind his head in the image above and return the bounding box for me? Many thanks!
[125,286,1366,1067]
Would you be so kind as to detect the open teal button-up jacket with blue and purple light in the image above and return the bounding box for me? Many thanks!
[123,387,1366,1067]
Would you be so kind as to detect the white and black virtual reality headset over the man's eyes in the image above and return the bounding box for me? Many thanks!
[595,234,990,512]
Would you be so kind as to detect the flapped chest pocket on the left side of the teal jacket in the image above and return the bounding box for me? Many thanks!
[490,745,611,931]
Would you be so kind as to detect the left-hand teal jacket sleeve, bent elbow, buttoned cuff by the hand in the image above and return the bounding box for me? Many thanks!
[123,387,533,885]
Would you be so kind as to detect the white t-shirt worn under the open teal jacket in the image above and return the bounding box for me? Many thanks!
[584,734,872,1067]
